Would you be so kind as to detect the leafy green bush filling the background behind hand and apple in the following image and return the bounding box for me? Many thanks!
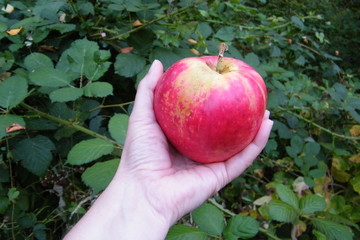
[0,0,360,240]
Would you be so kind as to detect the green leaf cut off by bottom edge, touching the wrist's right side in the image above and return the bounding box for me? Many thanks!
[165,225,208,240]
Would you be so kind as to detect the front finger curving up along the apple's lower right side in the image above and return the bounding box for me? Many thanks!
[225,119,273,181]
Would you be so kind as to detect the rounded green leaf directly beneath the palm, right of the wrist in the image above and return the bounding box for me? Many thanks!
[192,203,225,236]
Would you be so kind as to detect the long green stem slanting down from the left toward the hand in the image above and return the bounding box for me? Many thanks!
[20,102,123,149]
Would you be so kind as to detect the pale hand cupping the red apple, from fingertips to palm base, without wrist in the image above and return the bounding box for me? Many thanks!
[118,61,273,224]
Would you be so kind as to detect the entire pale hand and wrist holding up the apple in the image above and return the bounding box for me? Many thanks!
[65,60,273,240]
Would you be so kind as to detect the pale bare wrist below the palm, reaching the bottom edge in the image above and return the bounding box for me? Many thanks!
[65,174,170,240]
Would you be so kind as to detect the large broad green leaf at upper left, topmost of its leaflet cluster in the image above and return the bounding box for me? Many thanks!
[56,39,111,81]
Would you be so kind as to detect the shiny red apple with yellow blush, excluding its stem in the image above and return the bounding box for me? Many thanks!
[154,56,267,163]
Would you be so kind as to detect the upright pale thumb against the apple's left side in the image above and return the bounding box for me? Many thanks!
[131,60,163,120]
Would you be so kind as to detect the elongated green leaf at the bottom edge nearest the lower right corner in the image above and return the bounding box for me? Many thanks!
[311,218,354,240]
